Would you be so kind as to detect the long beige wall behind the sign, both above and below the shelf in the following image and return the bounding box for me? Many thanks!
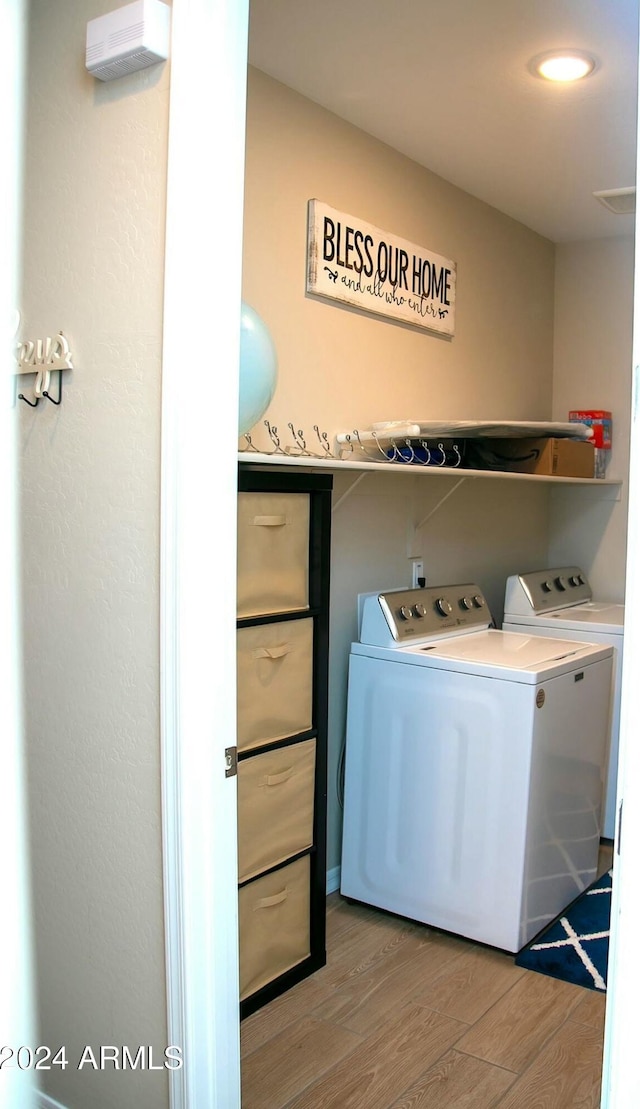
[243,69,555,871]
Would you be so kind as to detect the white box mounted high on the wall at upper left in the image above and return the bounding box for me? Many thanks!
[85,0,171,81]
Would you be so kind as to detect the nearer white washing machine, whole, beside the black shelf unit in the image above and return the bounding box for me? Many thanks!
[341,584,613,952]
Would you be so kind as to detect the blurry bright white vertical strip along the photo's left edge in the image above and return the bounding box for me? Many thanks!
[0,0,37,1109]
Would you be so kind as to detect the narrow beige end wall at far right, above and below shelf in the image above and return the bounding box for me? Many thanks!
[549,235,634,601]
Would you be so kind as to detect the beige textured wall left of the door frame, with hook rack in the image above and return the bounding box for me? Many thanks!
[20,0,169,1109]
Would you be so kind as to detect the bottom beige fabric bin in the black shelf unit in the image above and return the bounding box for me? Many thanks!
[238,855,311,1000]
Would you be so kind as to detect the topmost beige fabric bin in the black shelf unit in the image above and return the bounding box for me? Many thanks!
[237,492,309,618]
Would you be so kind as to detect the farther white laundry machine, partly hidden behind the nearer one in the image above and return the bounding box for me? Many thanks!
[502,566,624,840]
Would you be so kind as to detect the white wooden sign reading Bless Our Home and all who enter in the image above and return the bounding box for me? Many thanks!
[306,200,456,335]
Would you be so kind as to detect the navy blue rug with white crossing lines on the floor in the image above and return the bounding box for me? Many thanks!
[516,871,613,990]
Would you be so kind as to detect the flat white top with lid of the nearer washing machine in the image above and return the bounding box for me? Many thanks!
[396,628,613,684]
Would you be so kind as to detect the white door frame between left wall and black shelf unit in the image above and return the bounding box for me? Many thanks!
[161,0,248,1109]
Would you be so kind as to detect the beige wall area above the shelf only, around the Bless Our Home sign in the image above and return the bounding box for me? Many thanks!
[244,69,553,444]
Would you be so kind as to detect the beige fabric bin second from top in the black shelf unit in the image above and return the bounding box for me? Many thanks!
[236,617,313,751]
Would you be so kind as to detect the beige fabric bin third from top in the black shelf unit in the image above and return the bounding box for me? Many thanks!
[237,740,316,882]
